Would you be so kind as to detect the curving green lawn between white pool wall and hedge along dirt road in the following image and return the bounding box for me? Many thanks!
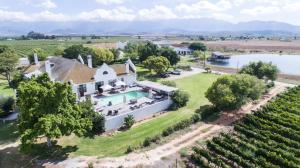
[60,74,218,157]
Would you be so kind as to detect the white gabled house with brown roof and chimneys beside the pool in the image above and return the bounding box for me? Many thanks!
[24,55,137,97]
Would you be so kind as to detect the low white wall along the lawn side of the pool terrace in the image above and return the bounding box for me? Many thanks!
[105,99,172,131]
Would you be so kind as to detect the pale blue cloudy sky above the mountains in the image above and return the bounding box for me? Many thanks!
[0,0,300,25]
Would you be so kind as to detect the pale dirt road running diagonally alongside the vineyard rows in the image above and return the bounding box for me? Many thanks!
[43,83,291,168]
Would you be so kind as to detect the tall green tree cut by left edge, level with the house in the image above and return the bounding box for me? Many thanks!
[0,46,18,85]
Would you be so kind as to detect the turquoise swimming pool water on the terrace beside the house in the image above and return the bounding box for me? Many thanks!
[100,91,149,106]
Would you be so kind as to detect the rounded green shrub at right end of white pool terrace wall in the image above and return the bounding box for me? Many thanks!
[171,90,190,110]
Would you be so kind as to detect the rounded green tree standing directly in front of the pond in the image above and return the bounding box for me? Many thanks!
[239,61,279,81]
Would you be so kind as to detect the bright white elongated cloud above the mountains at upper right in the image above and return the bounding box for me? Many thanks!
[241,6,280,16]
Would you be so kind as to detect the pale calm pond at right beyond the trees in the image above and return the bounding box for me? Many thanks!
[210,54,300,75]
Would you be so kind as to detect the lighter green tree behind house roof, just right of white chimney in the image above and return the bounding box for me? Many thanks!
[93,48,114,65]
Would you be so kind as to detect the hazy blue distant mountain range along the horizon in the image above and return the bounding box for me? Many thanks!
[0,18,300,36]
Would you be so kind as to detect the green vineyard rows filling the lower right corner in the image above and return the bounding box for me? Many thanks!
[191,86,300,168]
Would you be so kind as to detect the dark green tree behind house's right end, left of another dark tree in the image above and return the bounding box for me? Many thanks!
[138,41,159,62]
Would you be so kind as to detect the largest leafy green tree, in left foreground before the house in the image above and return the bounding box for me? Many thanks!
[18,74,92,147]
